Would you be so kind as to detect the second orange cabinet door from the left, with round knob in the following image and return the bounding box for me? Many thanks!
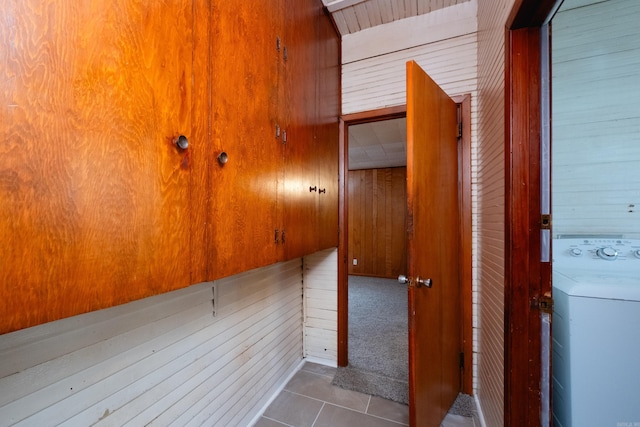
[207,0,285,280]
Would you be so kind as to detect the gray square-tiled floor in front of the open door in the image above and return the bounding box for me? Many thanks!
[255,362,474,427]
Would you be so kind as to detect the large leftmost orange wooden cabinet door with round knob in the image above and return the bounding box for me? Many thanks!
[0,0,199,333]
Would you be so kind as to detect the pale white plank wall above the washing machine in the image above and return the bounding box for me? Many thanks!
[552,0,640,238]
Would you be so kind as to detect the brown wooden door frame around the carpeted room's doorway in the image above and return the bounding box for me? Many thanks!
[337,94,473,394]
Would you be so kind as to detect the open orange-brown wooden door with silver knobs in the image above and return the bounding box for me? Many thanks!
[407,61,462,427]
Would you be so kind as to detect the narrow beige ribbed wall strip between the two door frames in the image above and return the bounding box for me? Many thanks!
[474,0,514,426]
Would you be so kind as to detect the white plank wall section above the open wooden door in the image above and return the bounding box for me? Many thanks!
[342,1,477,115]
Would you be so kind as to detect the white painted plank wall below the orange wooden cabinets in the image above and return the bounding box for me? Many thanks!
[0,256,310,426]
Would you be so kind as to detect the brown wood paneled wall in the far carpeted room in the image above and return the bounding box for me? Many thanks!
[347,167,407,278]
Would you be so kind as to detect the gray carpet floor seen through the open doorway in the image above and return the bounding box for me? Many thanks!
[333,276,475,417]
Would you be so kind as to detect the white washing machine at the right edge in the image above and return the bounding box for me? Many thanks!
[552,237,640,427]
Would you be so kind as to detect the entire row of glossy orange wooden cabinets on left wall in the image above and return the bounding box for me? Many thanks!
[0,0,340,334]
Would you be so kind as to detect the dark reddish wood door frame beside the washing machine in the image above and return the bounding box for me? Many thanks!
[504,0,562,426]
